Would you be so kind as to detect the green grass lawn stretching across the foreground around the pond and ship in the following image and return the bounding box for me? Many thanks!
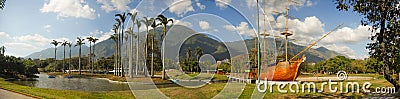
[0,74,398,99]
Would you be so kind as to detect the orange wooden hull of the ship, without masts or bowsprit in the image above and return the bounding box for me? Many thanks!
[260,56,305,81]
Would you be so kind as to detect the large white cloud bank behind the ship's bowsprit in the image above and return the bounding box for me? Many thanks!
[273,16,371,58]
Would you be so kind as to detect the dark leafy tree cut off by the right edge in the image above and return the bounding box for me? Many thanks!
[335,0,400,89]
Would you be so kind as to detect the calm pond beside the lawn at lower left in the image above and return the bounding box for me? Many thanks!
[10,73,130,91]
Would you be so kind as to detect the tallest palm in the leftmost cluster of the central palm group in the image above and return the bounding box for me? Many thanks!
[115,13,126,77]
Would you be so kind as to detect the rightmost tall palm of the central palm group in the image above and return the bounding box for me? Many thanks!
[157,15,174,79]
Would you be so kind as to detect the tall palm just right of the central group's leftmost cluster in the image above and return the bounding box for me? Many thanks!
[128,12,137,78]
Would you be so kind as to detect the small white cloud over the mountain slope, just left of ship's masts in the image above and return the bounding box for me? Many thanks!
[224,22,256,37]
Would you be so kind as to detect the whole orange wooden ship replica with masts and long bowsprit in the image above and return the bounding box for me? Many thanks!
[248,0,341,81]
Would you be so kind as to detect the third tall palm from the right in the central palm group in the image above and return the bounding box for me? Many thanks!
[142,17,154,76]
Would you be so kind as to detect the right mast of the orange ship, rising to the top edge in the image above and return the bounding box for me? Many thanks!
[281,0,293,61]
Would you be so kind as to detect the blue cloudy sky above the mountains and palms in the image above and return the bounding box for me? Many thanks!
[0,0,371,58]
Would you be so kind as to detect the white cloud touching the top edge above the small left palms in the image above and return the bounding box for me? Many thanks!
[40,0,96,20]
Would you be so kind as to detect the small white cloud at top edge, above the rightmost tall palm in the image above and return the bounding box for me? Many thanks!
[169,0,194,17]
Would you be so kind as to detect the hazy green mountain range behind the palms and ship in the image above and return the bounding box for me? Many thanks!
[25,25,343,62]
